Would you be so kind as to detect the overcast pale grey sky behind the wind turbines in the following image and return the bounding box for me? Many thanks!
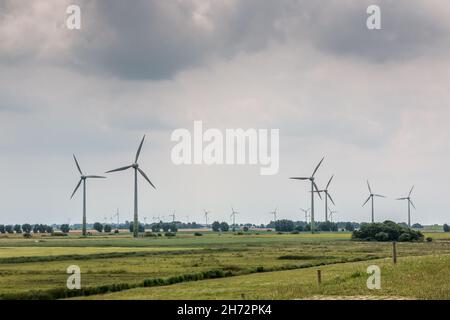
[0,0,450,224]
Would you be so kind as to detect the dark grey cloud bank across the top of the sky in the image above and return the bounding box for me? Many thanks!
[0,0,449,80]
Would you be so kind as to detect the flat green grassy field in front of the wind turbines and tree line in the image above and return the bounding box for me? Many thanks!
[0,232,450,299]
